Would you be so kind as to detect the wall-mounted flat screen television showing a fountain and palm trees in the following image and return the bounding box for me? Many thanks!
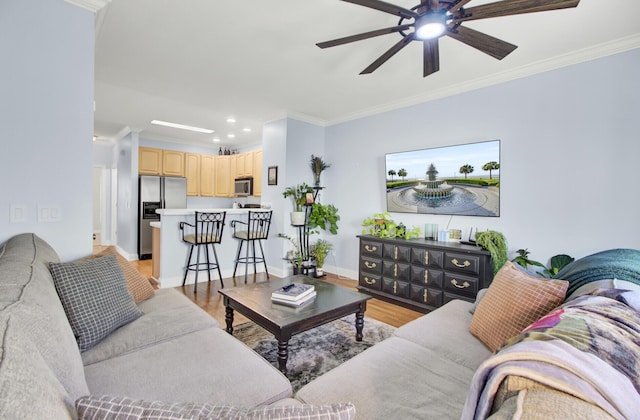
[385,140,500,217]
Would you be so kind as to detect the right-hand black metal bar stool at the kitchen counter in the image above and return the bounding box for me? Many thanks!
[231,210,273,283]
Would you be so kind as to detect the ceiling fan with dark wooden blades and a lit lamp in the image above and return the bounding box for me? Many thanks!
[316,0,580,77]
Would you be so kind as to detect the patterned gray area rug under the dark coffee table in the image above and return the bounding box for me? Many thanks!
[233,315,395,392]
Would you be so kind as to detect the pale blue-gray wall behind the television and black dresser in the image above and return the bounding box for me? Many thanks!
[325,50,640,278]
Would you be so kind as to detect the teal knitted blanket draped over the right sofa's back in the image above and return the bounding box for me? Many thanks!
[553,248,640,296]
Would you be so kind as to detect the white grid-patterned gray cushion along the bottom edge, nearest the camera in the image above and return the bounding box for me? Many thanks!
[76,396,355,420]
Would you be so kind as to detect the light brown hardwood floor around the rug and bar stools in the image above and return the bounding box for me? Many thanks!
[127,260,423,327]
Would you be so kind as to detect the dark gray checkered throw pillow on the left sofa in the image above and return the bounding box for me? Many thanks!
[49,254,142,351]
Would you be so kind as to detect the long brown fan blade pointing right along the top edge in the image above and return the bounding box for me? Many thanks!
[454,0,580,22]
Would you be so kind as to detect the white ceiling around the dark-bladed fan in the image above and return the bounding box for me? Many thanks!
[95,0,640,148]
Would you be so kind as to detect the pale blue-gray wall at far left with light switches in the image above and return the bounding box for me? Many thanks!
[0,0,94,260]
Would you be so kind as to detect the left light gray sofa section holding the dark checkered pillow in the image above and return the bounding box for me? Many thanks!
[0,234,292,419]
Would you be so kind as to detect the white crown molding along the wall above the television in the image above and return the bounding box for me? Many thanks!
[325,34,640,126]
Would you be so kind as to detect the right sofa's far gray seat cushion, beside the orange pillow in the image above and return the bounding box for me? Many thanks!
[396,300,491,370]
